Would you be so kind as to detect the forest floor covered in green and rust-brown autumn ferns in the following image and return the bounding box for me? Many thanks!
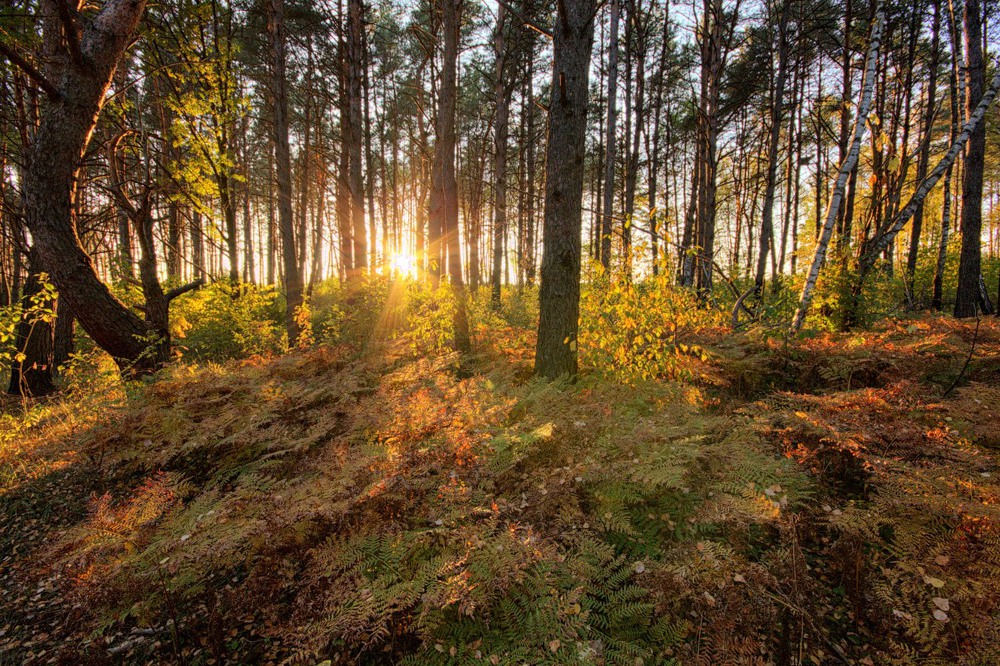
[0,317,1000,665]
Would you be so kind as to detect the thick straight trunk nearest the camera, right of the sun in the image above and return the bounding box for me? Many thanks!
[535,0,596,379]
